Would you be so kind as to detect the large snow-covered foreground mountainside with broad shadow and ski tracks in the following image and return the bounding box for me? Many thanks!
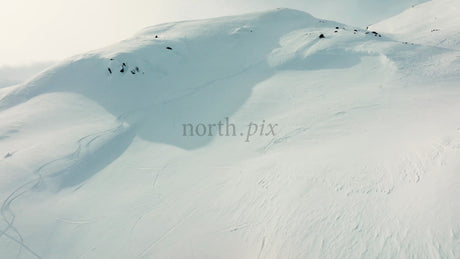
[0,6,460,258]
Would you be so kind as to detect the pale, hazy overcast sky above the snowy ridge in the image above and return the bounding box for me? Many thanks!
[0,0,424,66]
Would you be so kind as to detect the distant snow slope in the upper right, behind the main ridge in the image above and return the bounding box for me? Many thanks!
[371,0,460,50]
